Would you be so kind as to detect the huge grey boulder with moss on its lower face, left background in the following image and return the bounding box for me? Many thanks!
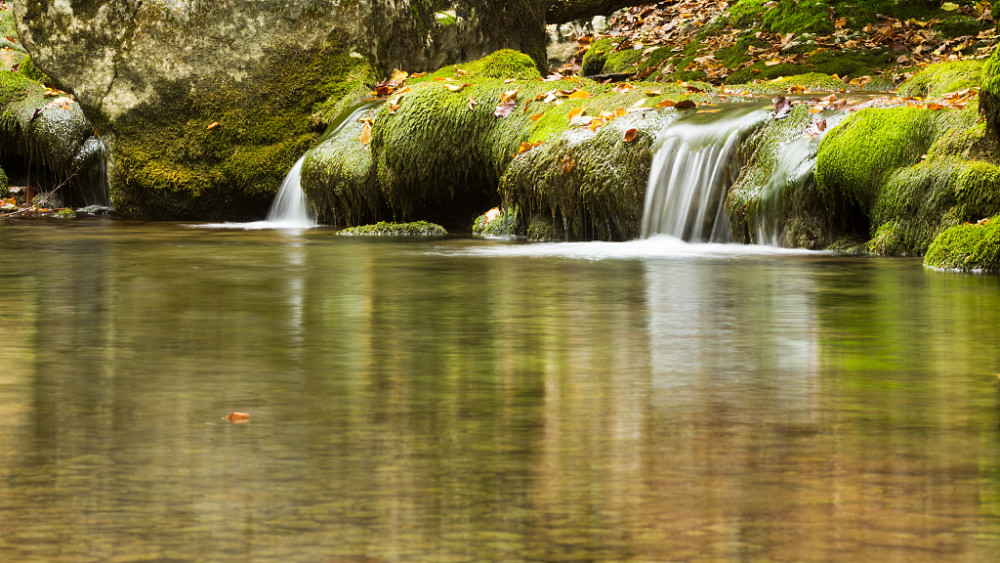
[16,0,545,218]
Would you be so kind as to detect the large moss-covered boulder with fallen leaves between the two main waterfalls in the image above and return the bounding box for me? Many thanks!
[302,51,718,240]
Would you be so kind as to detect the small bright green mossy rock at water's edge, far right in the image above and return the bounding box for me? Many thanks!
[924,215,1000,272]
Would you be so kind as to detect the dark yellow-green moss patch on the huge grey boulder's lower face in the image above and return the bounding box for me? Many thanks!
[111,32,372,219]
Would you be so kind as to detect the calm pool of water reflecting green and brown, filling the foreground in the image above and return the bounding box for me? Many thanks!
[0,222,1000,562]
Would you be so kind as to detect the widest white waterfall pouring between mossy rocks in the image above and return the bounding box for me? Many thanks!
[642,104,772,242]
